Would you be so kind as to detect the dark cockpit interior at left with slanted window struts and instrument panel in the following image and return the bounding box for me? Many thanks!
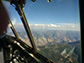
[0,0,53,63]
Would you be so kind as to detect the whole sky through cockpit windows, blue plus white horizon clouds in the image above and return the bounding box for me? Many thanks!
[3,0,80,31]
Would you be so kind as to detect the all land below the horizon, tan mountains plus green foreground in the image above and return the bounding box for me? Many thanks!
[9,30,81,63]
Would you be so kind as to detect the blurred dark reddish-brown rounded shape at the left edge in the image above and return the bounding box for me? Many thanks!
[0,0,9,35]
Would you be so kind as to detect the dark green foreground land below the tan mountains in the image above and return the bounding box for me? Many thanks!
[38,40,80,63]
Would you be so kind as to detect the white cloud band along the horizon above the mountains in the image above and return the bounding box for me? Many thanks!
[11,23,80,31]
